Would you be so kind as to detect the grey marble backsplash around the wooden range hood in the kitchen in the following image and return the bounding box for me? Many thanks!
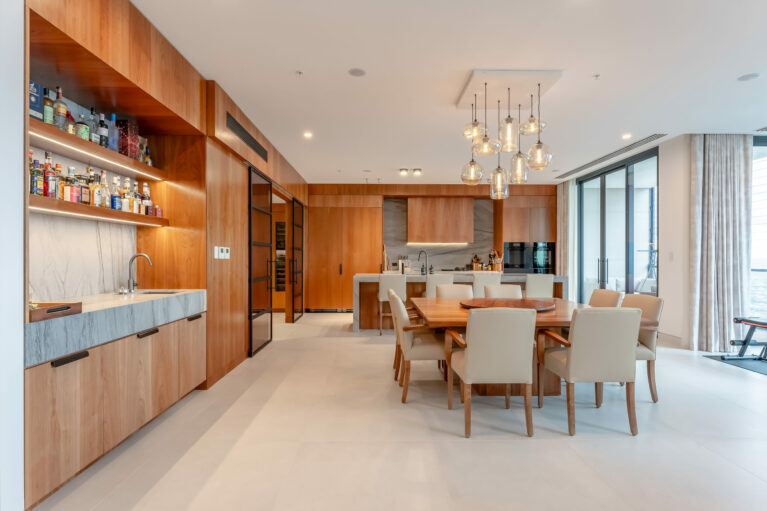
[383,199,493,271]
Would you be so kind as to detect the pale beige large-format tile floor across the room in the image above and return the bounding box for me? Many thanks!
[38,314,767,511]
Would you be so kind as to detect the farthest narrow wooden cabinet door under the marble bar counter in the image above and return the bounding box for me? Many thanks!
[177,312,205,397]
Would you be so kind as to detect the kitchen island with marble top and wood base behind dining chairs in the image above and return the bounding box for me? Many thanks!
[352,271,568,332]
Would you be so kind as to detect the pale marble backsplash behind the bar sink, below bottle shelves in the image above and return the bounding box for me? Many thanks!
[29,213,138,301]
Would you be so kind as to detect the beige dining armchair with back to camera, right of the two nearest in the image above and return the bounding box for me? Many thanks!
[538,307,642,435]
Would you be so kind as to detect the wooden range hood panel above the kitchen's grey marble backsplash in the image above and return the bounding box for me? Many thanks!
[407,197,474,243]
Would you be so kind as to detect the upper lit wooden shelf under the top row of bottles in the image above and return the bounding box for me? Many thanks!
[29,117,165,181]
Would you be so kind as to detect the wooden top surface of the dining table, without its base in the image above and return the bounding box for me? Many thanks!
[410,297,658,329]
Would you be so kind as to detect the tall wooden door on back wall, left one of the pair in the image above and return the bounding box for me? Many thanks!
[306,207,344,309]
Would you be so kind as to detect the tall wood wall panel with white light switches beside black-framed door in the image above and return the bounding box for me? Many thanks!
[205,138,249,387]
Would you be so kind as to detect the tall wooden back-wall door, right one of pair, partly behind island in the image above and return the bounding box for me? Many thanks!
[341,208,383,309]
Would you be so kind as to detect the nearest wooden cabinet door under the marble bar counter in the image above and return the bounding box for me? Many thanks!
[24,348,104,507]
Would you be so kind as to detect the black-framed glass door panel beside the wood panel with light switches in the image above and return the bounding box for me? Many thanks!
[248,167,272,356]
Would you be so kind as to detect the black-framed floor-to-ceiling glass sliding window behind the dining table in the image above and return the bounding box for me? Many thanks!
[577,148,658,303]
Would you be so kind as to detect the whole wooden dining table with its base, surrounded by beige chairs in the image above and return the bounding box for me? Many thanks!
[409,297,658,396]
